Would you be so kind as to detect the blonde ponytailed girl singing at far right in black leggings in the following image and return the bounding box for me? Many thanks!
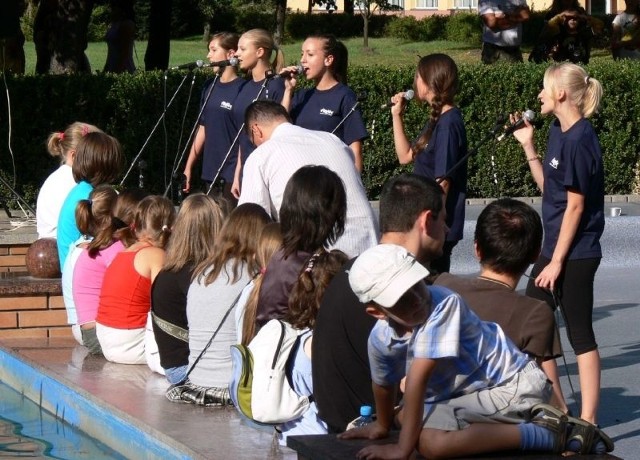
[512,63,604,423]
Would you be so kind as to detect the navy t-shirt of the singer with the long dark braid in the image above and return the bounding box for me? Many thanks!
[414,107,467,241]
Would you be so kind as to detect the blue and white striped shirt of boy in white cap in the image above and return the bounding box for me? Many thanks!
[369,286,529,402]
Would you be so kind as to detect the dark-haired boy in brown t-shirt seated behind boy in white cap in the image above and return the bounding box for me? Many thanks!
[434,198,567,412]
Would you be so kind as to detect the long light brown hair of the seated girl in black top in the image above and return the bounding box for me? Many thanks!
[163,193,225,272]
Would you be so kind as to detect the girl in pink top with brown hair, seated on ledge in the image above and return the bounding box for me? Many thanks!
[74,186,146,355]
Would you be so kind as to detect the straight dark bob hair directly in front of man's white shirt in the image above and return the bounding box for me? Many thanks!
[280,166,347,257]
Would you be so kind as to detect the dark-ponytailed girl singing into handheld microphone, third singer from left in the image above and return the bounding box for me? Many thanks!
[282,34,369,172]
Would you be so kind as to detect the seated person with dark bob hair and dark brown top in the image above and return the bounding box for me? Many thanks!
[256,166,347,329]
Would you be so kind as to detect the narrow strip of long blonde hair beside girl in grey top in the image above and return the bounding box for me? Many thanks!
[241,222,282,345]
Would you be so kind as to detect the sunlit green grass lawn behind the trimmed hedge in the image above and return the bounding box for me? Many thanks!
[24,37,611,73]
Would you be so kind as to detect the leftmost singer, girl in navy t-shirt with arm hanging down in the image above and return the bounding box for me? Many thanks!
[183,32,245,205]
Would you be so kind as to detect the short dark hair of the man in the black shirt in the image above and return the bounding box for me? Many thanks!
[380,174,444,233]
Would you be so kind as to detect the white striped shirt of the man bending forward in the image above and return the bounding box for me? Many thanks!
[238,123,378,257]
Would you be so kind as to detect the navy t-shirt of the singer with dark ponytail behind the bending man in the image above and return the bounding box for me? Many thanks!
[291,83,369,145]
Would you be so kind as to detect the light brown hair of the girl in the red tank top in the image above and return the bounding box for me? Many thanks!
[133,195,176,249]
